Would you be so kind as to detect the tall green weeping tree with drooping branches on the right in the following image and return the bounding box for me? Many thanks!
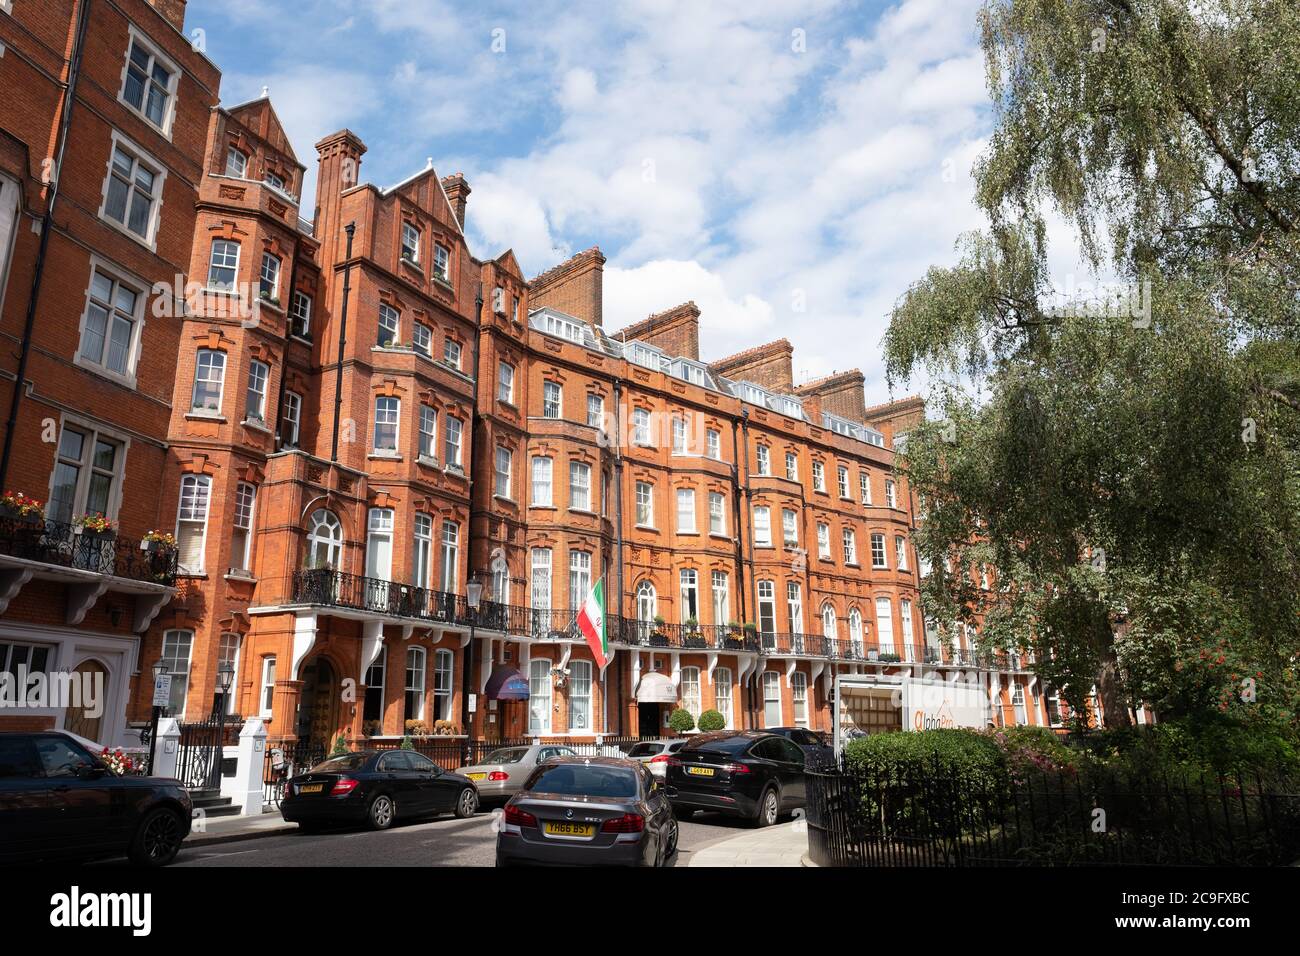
[884,0,1300,724]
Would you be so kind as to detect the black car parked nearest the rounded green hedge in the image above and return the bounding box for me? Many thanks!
[668,731,807,826]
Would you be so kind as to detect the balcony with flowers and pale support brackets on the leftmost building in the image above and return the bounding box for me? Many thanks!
[0,514,177,632]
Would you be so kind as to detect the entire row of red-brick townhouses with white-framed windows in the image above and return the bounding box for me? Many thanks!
[0,0,1056,744]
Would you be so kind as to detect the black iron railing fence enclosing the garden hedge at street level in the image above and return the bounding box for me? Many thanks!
[807,761,1300,866]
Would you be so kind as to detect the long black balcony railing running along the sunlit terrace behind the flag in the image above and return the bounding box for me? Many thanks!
[279,568,1024,669]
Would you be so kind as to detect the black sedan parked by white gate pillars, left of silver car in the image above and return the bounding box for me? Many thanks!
[280,750,478,830]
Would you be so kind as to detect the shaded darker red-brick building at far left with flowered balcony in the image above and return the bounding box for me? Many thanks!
[0,0,218,741]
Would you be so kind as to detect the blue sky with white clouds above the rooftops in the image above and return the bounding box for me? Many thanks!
[186,0,992,405]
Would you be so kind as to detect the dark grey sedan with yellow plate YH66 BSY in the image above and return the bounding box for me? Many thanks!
[497,757,677,866]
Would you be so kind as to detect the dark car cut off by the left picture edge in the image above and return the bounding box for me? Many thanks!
[0,731,194,866]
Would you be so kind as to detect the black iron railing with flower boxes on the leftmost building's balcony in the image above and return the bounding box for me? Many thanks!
[0,515,177,587]
